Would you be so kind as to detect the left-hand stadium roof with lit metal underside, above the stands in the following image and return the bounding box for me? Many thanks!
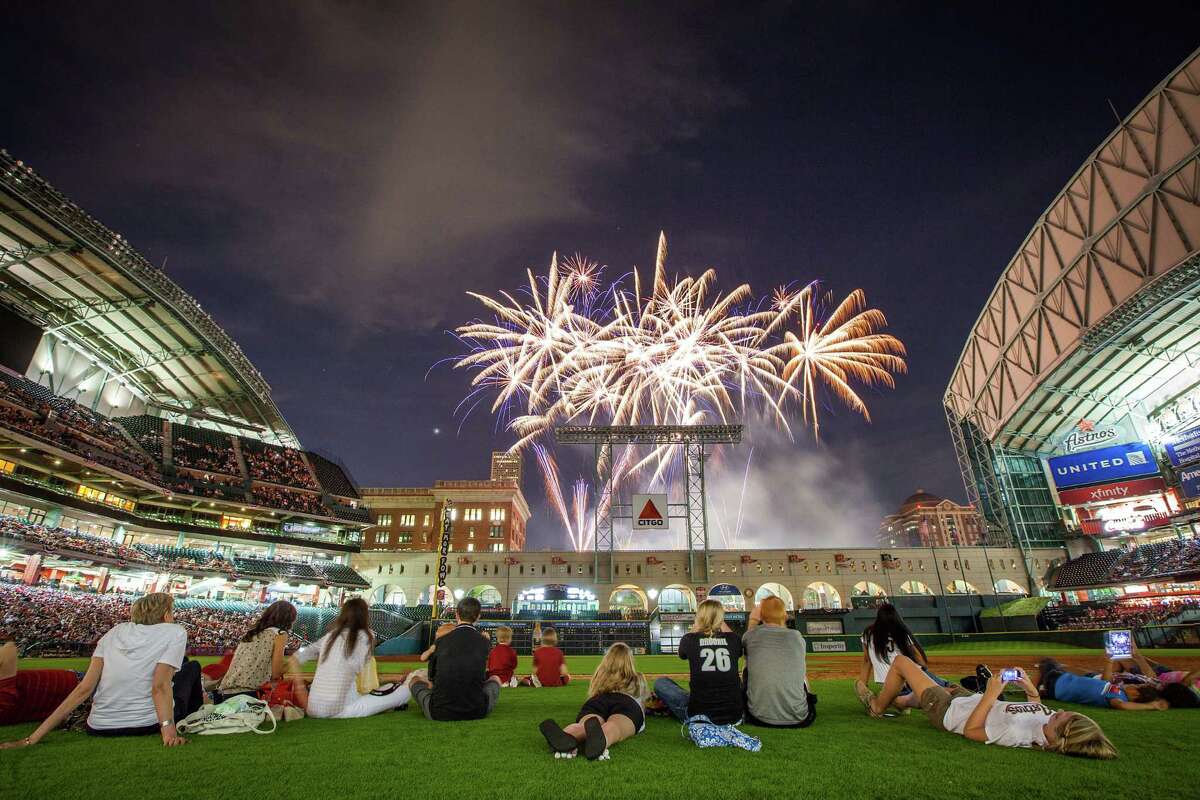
[0,151,299,446]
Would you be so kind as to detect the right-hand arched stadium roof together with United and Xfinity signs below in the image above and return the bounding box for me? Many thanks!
[944,50,1200,546]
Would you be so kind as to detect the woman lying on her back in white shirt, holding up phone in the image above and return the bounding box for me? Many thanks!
[854,656,1117,758]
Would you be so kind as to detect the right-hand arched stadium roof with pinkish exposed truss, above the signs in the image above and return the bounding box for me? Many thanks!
[944,50,1200,452]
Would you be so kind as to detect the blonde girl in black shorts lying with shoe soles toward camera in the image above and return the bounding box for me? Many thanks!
[538,642,649,760]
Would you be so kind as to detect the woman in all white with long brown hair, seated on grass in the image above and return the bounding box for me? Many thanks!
[292,597,410,720]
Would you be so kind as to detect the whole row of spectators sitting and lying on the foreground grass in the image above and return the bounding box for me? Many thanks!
[0,593,1200,759]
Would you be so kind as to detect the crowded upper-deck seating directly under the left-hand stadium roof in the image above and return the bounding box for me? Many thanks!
[0,371,371,523]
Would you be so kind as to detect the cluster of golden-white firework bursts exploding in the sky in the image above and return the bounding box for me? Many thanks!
[456,235,905,549]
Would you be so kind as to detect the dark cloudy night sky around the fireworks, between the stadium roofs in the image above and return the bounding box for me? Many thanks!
[0,2,1200,547]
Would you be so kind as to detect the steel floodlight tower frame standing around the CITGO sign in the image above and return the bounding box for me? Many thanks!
[554,425,742,583]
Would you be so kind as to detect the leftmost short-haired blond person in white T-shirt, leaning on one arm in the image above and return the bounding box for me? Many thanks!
[0,593,199,747]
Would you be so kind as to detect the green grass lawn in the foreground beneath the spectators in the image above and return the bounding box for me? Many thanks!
[0,658,1200,800]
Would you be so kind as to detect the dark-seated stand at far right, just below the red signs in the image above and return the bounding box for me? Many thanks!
[1050,540,1200,589]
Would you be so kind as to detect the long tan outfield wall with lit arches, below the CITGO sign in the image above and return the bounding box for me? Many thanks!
[352,539,1066,609]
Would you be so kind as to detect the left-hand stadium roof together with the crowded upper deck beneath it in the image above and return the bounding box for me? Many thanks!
[0,151,370,551]
